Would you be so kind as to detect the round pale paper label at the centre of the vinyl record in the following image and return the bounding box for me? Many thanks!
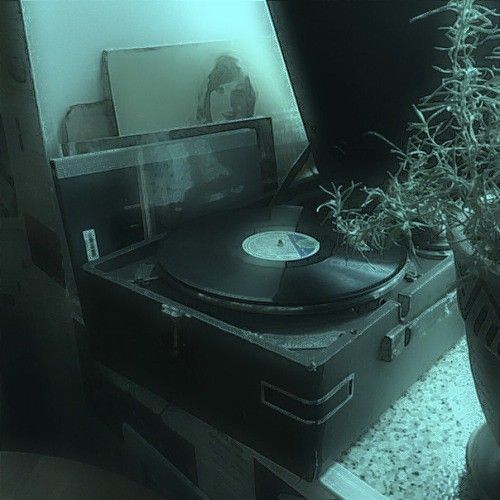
[241,231,320,262]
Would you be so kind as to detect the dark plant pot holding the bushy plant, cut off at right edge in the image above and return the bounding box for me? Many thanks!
[450,231,500,499]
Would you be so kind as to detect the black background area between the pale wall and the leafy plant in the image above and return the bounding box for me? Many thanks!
[268,0,500,185]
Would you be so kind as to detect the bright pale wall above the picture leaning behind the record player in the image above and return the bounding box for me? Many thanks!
[22,0,273,156]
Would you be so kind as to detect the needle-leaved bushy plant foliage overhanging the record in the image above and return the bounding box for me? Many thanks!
[318,0,500,264]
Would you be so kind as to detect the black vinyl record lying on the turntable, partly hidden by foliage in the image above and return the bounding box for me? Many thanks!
[158,206,406,313]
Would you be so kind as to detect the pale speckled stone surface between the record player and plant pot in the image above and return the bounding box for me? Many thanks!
[340,339,484,500]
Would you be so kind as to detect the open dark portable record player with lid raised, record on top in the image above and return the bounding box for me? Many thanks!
[52,2,463,480]
